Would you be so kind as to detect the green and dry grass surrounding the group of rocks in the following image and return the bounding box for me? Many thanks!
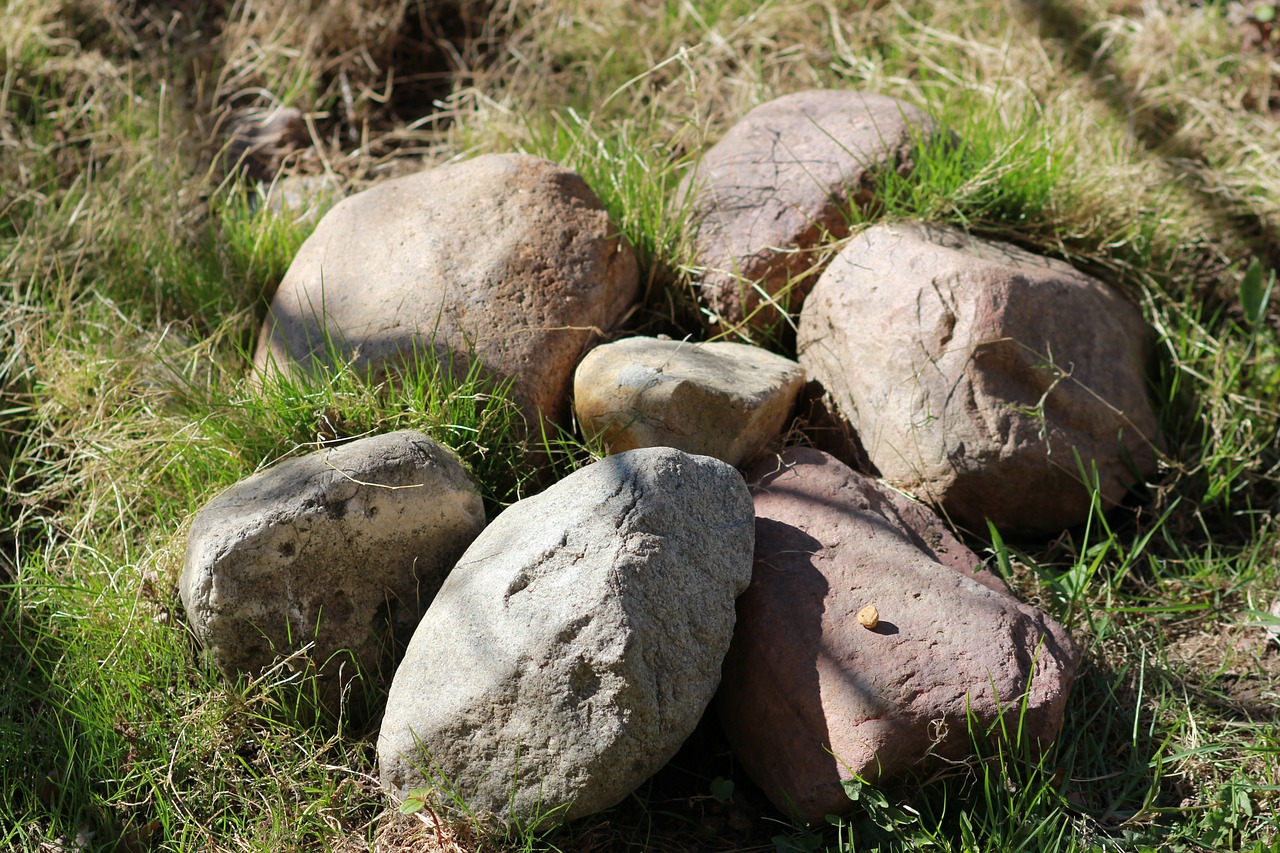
[0,0,1280,852]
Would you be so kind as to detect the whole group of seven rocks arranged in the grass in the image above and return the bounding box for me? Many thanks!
[180,92,1155,824]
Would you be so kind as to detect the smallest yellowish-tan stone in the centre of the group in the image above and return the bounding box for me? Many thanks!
[573,337,804,466]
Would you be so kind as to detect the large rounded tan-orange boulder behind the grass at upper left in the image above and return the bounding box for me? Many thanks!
[255,154,639,427]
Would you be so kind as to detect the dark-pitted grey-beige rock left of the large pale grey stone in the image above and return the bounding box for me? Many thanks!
[179,432,485,707]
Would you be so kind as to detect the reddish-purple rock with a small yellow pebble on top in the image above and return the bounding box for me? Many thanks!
[716,448,1079,821]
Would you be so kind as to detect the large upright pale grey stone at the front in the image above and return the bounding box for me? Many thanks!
[378,447,754,826]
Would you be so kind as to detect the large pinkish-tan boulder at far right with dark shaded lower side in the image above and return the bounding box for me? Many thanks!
[797,223,1156,535]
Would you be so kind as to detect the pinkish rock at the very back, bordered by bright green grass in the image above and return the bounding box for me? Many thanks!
[677,90,934,325]
